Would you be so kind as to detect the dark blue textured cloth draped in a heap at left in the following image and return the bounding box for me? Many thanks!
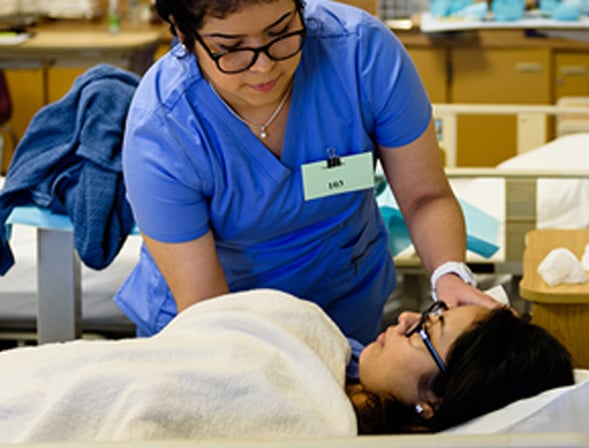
[0,64,139,275]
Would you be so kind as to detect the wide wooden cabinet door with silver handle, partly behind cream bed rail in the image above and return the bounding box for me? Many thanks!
[450,48,551,166]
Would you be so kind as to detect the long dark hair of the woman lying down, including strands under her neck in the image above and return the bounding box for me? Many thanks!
[348,308,574,434]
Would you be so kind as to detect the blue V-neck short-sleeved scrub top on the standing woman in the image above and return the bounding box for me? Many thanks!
[115,1,431,343]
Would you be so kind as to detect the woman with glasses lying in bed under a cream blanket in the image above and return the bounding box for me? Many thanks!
[0,290,573,443]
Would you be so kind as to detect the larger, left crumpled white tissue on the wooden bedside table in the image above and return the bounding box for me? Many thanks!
[538,247,587,286]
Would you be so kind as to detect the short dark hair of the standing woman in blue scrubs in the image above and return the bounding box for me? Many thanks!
[155,0,304,52]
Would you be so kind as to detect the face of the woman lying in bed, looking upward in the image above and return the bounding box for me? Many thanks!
[360,305,489,405]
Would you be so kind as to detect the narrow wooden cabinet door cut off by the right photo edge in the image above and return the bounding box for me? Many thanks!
[554,51,589,100]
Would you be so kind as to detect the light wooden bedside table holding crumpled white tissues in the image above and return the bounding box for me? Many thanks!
[520,229,589,368]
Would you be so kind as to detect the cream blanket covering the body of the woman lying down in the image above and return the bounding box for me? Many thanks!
[0,290,356,443]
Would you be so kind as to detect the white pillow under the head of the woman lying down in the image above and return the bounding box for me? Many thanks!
[444,369,589,434]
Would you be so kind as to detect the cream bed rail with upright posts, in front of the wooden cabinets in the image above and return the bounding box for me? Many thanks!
[433,104,589,167]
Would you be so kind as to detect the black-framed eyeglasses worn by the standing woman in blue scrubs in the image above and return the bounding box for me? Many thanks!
[194,12,307,74]
